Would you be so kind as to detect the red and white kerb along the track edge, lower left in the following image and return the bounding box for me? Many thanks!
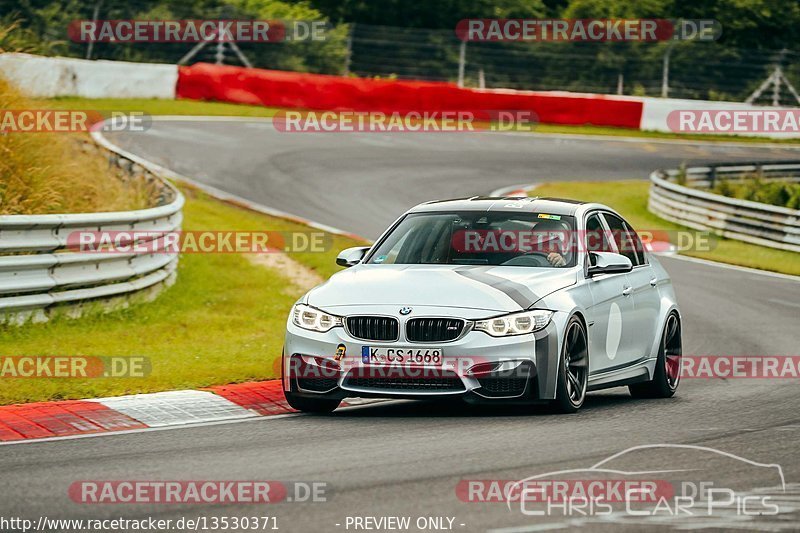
[0,380,380,442]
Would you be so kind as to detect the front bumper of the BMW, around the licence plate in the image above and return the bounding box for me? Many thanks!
[282,321,559,403]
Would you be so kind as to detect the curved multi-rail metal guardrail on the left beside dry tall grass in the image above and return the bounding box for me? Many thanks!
[0,132,184,324]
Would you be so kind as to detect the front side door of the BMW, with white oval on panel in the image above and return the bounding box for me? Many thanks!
[584,211,633,374]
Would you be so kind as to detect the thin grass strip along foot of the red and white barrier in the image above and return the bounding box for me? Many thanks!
[31,98,800,144]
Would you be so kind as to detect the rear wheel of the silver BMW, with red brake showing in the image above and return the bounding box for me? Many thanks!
[628,312,683,398]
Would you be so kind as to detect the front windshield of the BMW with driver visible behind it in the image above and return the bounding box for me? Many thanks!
[367,211,576,268]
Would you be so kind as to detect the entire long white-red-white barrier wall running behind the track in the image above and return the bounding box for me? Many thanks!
[0,54,800,138]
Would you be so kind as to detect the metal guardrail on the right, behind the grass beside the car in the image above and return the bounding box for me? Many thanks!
[647,161,800,252]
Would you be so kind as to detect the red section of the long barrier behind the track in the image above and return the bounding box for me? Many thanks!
[176,63,642,128]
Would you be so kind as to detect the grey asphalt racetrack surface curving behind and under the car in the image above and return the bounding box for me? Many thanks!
[0,120,800,532]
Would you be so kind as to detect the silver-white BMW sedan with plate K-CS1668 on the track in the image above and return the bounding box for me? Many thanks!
[282,197,682,413]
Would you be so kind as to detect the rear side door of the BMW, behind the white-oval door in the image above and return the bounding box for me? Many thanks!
[603,212,661,362]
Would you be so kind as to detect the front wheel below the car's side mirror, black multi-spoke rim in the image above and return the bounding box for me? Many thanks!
[551,316,589,413]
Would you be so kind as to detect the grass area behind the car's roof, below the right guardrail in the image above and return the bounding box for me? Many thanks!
[530,180,800,276]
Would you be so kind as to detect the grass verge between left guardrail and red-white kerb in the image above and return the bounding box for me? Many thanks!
[0,188,366,404]
